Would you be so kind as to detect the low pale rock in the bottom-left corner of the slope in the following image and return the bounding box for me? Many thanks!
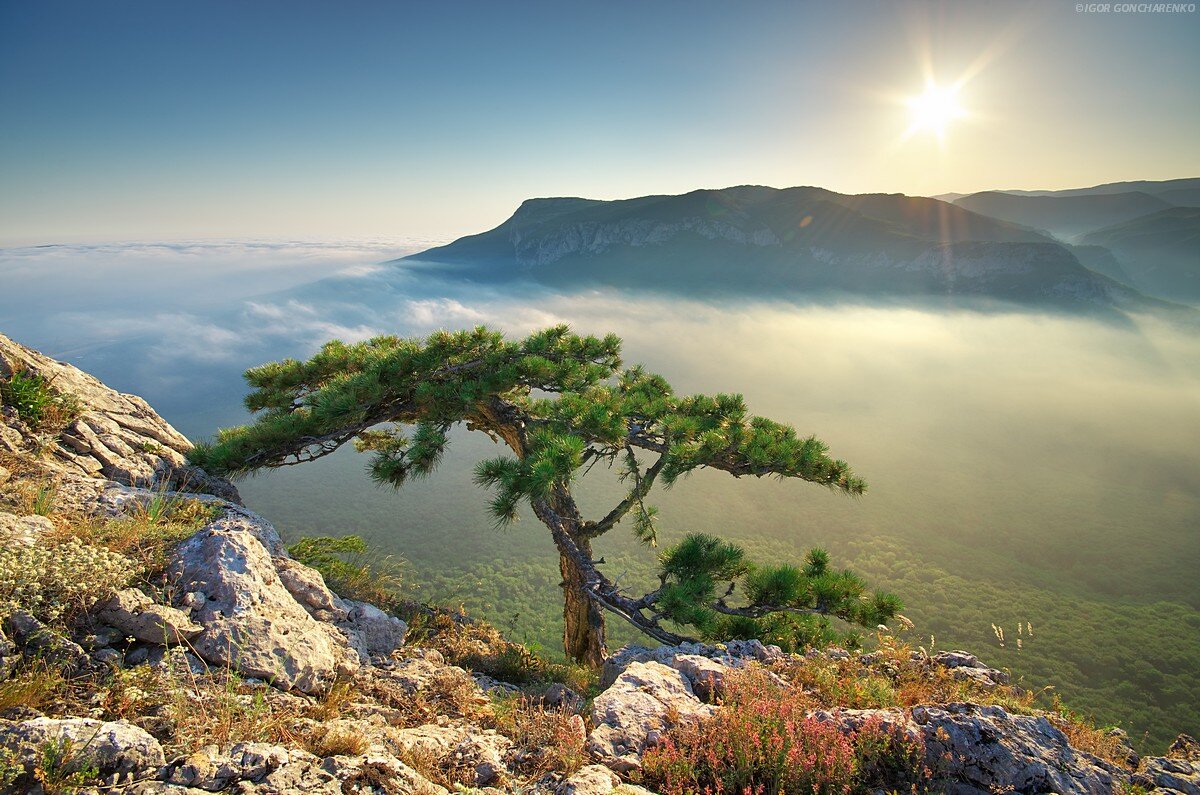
[0,718,166,779]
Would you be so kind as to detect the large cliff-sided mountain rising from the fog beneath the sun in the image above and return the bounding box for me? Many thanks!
[406,186,1180,317]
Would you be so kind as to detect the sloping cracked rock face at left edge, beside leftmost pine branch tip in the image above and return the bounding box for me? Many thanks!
[0,334,241,503]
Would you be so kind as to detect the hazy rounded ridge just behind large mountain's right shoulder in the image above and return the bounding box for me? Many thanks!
[954,191,1174,239]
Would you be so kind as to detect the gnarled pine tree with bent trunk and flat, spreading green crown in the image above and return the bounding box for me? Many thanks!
[192,325,900,664]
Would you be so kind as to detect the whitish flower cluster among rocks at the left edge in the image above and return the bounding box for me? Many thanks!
[0,538,136,621]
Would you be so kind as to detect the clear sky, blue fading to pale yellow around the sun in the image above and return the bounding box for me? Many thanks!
[0,0,1200,246]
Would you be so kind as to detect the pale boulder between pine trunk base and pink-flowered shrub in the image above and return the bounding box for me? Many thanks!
[588,662,716,773]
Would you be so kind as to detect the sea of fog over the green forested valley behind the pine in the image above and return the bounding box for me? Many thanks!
[0,240,1200,742]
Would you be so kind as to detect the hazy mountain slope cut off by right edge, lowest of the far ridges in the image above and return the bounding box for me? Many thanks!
[1081,207,1200,303]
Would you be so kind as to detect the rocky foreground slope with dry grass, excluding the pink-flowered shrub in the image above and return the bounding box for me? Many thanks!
[0,335,1200,795]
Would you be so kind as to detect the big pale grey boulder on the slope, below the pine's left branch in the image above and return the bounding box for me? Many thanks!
[172,518,359,693]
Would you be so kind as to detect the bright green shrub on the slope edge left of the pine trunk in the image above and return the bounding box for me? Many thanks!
[288,536,403,611]
